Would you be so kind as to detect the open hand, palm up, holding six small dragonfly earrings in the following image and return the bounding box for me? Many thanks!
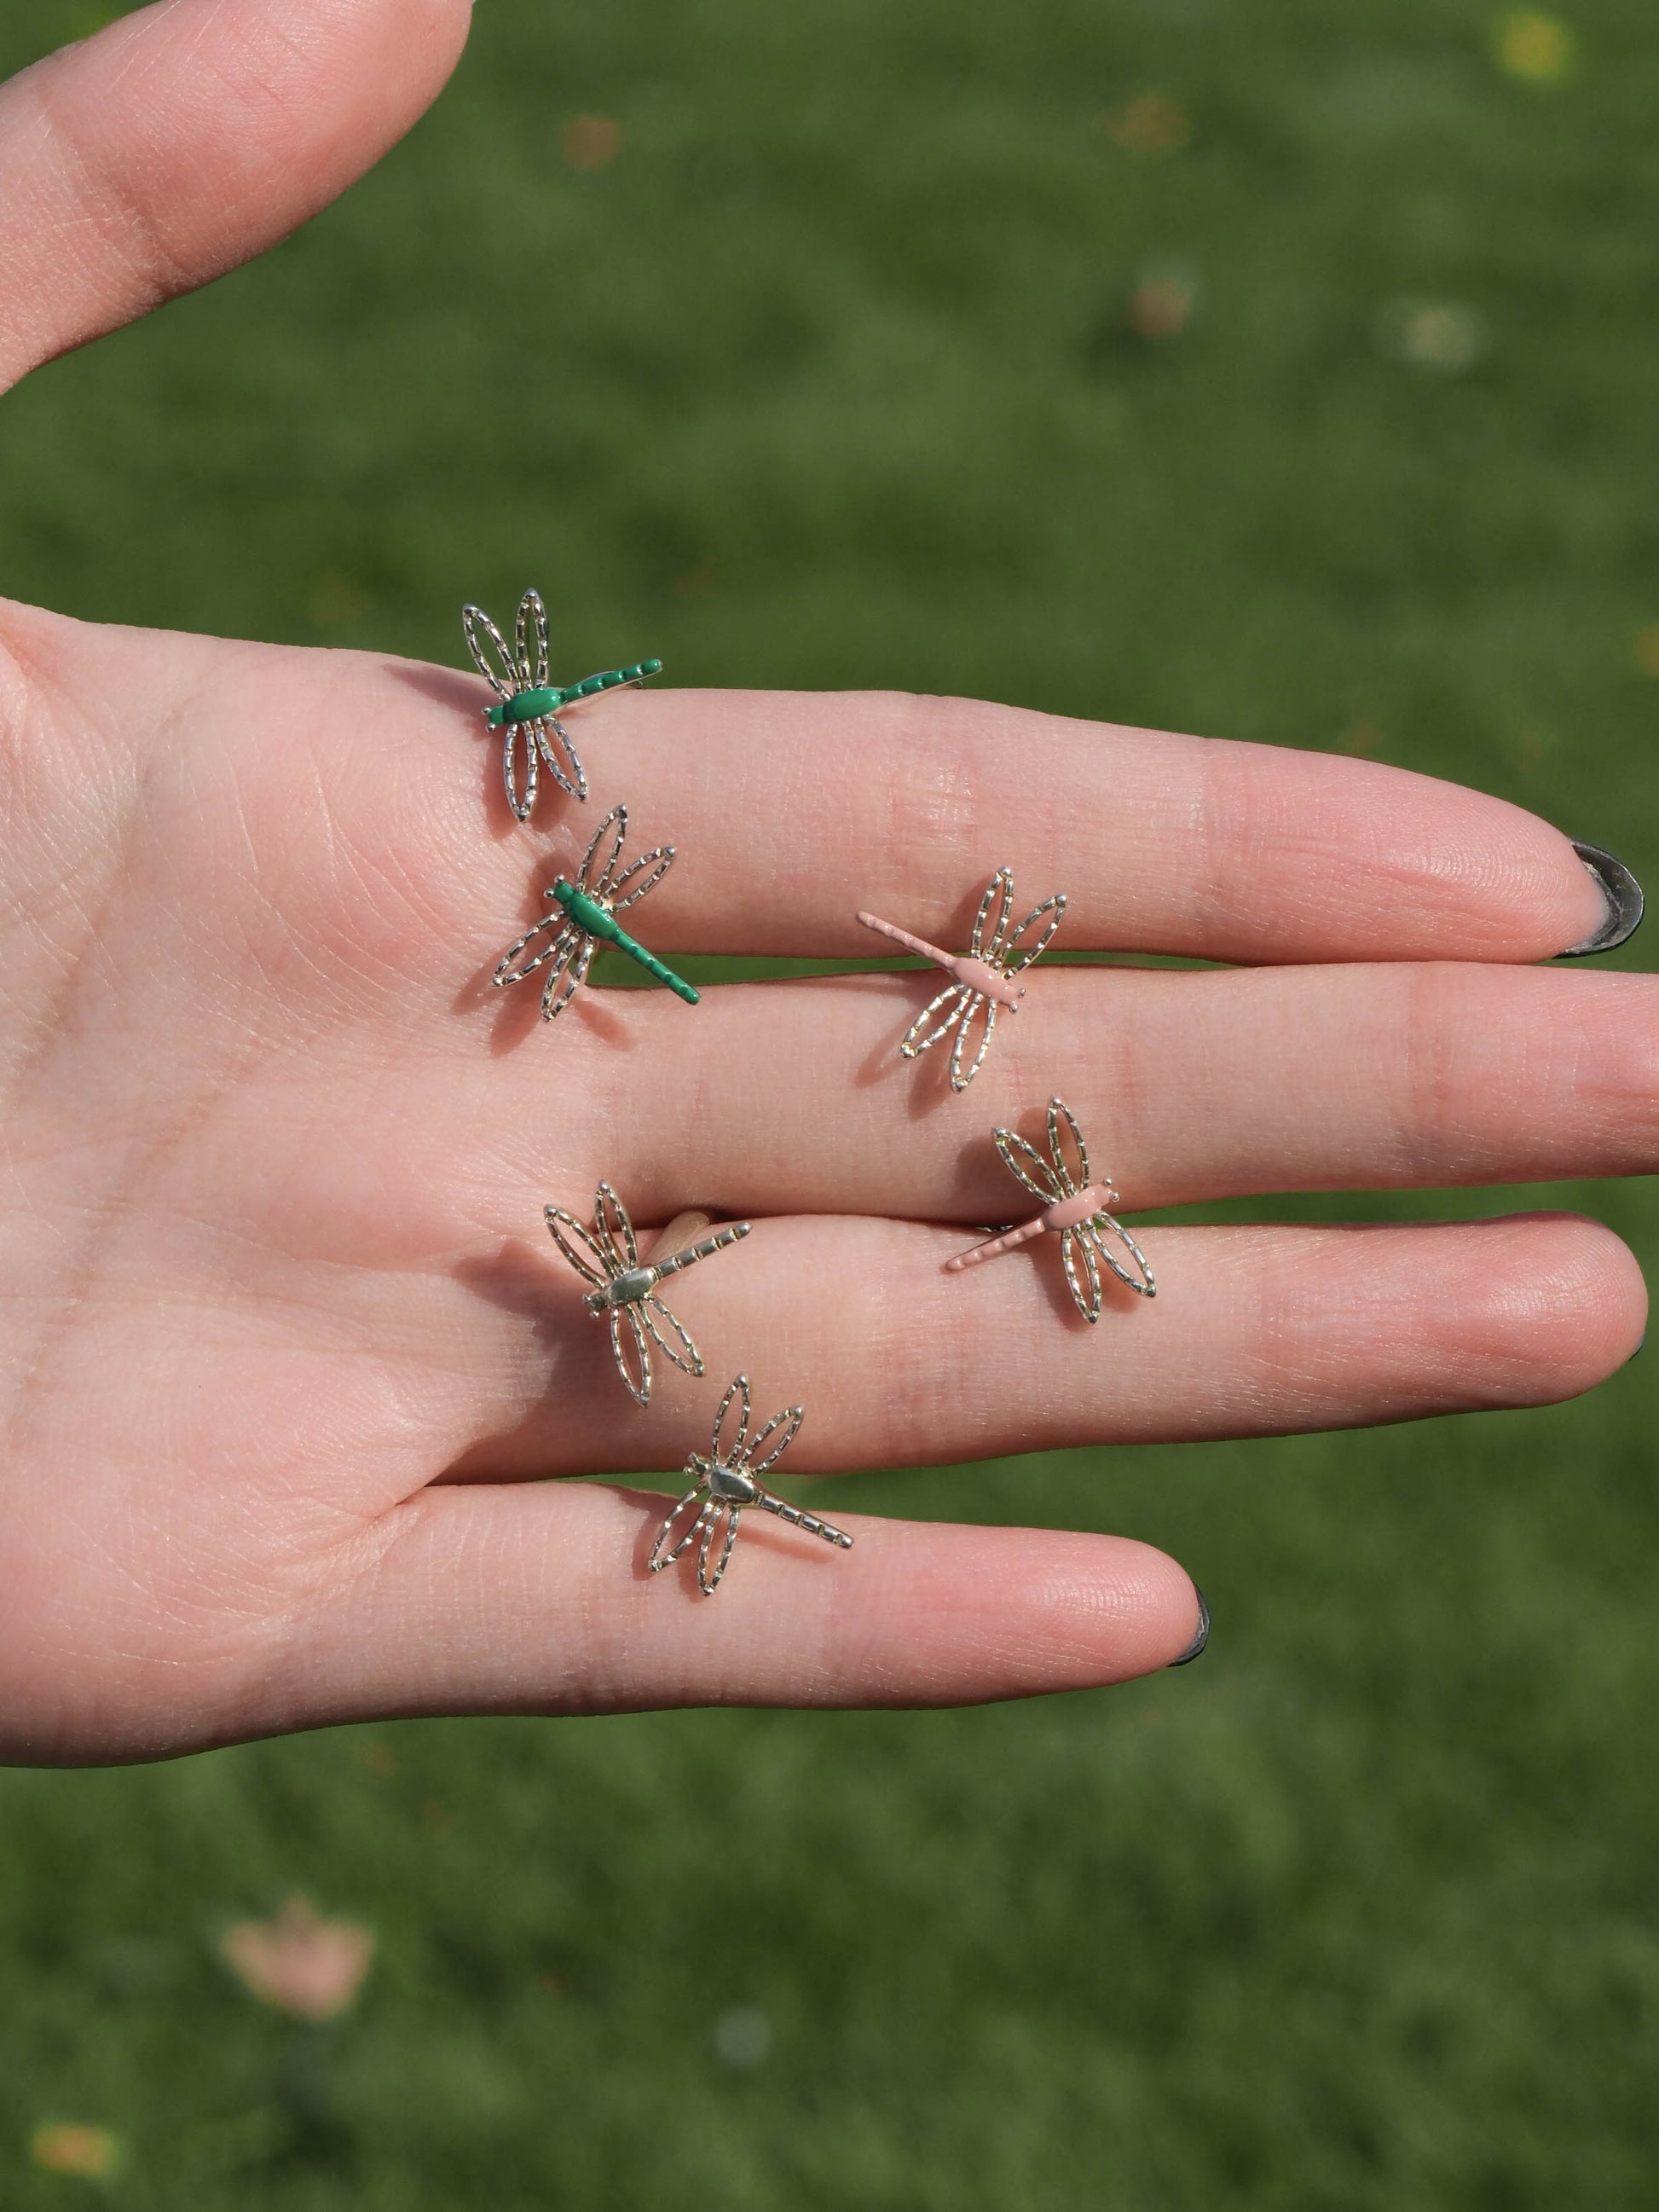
[0,0,1659,1761]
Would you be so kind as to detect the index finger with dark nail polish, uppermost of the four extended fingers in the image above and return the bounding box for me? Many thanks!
[570,690,1608,962]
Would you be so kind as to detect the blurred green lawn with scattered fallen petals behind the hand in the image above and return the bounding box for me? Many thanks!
[0,0,1659,2212]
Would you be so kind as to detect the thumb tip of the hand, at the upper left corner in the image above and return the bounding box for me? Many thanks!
[0,0,471,391]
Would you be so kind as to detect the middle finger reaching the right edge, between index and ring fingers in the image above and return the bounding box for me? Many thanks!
[456,962,1659,1221]
